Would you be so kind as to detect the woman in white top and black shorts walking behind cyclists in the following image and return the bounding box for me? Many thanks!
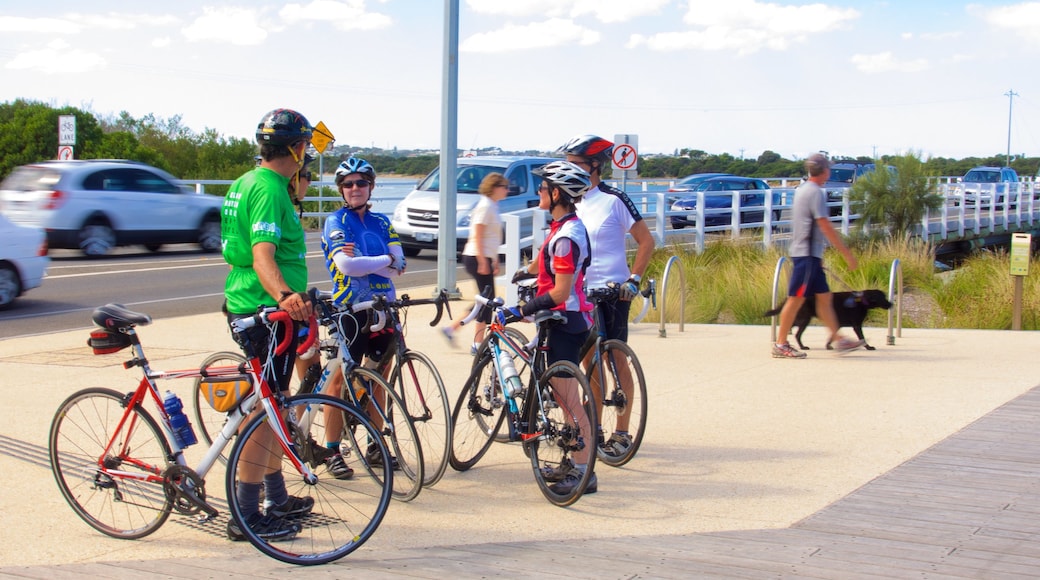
[442,173,510,354]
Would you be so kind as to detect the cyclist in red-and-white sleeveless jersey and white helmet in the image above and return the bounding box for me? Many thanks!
[506,160,598,494]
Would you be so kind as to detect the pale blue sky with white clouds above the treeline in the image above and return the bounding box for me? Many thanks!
[0,0,1040,164]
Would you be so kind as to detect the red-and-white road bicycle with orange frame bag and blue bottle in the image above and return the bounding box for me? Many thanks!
[49,305,393,564]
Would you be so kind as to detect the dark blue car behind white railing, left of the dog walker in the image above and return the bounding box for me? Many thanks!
[671,176,780,230]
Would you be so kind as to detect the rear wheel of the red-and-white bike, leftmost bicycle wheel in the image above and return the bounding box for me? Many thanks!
[48,388,174,539]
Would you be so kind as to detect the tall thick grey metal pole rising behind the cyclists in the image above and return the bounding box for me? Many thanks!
[435,0,459,294]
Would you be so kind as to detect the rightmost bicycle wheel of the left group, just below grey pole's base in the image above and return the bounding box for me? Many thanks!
[390,350,451,487]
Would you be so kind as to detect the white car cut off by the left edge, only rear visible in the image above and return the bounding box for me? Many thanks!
[0,215,50,309]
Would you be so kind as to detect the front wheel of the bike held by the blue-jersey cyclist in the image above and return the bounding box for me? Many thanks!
[344,367,425,501]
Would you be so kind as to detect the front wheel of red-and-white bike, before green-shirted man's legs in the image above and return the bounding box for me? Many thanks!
[227,395,393,565]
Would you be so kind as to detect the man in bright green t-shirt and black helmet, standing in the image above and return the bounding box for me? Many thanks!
[220,109,314,541]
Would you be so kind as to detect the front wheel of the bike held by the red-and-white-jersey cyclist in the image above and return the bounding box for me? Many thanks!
[448,350,508,471]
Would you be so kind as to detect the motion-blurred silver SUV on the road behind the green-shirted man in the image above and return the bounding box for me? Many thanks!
[0,160,224,256]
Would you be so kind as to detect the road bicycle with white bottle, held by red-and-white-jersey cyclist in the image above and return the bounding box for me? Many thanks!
[448,295,596,506]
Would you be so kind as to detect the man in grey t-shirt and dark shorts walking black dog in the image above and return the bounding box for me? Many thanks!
[773,153,863,359]
